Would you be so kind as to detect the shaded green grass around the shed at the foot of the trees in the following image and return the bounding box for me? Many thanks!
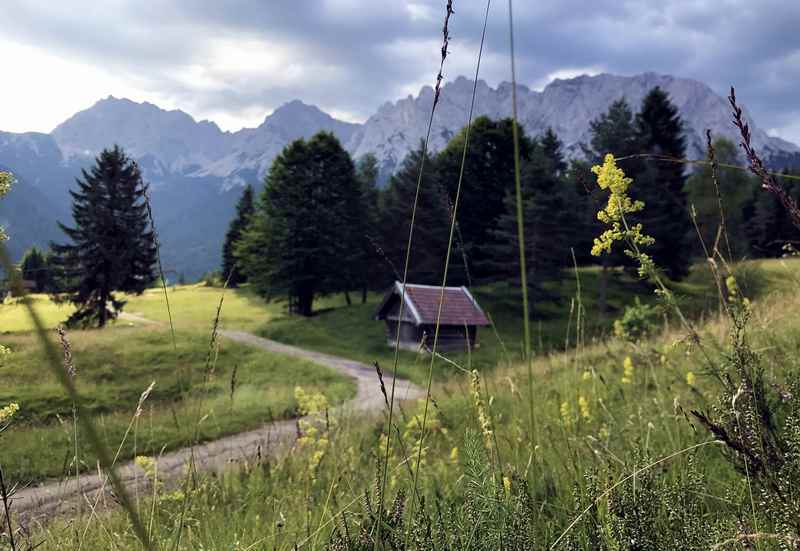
[257,268,713,383]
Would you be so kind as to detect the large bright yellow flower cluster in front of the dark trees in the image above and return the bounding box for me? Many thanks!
[592,153,655,264]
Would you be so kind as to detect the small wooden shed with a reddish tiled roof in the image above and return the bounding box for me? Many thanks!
[375,281,489,351]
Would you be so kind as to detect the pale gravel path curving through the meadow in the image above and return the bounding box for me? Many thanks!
[13,313,425,523]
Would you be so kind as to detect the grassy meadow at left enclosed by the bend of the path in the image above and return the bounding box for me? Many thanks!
[0,320,355,481]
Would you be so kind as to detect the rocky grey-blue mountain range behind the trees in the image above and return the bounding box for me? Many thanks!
[0,73,800,278]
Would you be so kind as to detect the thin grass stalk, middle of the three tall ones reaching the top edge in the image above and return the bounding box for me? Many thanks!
[401,0,492,547]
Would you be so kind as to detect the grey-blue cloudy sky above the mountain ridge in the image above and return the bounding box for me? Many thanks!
[0,0,800,143]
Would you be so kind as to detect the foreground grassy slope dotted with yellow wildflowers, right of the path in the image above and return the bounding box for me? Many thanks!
[29,260,800,549]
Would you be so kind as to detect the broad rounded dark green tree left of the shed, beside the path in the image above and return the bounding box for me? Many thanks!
[235,132,360,316]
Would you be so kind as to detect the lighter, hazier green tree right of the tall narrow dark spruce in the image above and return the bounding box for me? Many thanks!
[686,138,758,260]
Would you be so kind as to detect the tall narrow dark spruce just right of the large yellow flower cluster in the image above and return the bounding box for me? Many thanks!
[631,87,692,279]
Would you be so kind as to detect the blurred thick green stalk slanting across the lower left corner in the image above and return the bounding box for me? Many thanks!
[0,242,153,549]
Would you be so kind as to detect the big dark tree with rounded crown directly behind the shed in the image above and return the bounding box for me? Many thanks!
[437,117,532,279]
